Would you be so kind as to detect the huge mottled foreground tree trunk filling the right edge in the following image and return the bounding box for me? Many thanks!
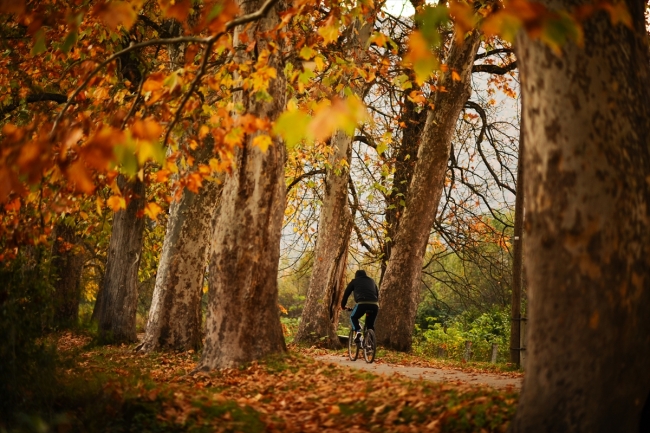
[512,0,650,433]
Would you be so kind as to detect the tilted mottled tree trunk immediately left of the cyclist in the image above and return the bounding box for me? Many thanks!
[295,131,352,349]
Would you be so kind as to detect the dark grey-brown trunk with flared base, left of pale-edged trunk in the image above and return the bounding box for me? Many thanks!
[93,175,145,342]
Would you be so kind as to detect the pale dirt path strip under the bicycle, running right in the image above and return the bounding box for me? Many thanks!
[315,355,522,389]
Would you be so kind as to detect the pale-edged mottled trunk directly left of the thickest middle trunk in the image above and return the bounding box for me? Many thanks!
[138,168,222,352]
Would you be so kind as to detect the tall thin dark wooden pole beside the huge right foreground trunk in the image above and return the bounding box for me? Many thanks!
[510,114,524,366]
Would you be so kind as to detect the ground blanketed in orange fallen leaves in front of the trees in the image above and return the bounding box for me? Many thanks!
[5,333,518,432]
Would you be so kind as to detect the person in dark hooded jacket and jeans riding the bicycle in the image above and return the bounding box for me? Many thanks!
[341,269,379,343]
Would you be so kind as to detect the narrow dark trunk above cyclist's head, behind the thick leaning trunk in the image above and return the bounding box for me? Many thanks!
[380,86,427,285]
